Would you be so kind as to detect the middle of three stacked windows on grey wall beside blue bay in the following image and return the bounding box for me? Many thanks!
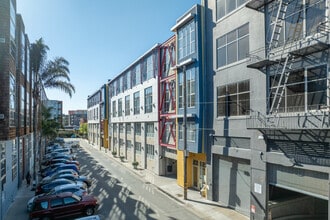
[216,24,249,68]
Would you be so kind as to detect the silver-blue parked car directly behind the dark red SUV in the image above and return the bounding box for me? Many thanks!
[26,183,88,212]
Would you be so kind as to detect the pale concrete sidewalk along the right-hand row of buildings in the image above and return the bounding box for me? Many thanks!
[82,140,249,220]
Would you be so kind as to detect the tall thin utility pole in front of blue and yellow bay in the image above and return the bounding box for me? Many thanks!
[183,65,188,200]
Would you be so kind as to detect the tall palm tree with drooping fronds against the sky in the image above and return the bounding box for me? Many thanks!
[30,38,75,181]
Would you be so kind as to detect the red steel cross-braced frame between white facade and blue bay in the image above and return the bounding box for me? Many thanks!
[158,36,176,149]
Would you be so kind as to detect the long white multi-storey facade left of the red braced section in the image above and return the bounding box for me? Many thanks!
[108,44,162,174]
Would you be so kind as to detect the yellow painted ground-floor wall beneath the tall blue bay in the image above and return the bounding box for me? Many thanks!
[177,150,206,187]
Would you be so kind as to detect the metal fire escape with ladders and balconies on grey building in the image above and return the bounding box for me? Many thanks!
[246,0,330,129]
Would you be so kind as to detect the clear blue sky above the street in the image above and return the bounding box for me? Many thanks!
[17,0,201,114]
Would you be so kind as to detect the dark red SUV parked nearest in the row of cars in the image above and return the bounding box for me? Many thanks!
[30,192,99,220]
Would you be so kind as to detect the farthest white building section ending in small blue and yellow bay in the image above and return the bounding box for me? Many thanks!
[87,84,109,148]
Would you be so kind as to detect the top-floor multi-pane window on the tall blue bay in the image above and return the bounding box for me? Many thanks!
[178,20,196,60]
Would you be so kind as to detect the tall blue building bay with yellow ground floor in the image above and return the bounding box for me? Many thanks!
[171,5,213,189]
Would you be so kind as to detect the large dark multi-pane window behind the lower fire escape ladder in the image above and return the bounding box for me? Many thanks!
[270,65,328,112]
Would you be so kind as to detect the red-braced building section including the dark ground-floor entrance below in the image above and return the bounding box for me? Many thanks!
[158,36,177,175]
